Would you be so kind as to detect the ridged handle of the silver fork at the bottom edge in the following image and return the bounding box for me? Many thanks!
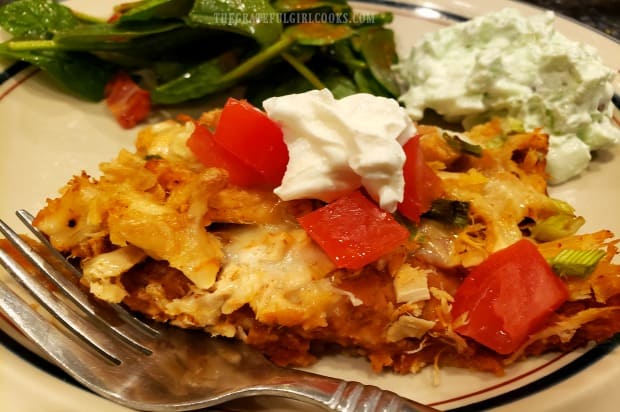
[263,371,438,412]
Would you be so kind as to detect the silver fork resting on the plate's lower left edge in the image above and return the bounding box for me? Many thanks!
[0,210,436,412]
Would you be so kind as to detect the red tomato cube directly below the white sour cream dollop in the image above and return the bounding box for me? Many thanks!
[298,190,409,270]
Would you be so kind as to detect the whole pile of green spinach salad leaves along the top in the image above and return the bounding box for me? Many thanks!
[0,0,399,111]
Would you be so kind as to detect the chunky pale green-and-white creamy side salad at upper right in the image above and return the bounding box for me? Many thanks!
[398,9,620,183]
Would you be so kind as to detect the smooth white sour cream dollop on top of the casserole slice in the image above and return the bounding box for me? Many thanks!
[263,89,416,212]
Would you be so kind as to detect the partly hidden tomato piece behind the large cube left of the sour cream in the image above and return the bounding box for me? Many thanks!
[187,123,263,187]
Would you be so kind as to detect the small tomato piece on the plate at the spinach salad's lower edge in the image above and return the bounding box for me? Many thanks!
[105,72,151,129]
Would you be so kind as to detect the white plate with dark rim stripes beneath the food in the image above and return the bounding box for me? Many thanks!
[0,0,620,412]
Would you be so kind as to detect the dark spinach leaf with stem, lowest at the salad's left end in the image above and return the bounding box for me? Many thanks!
[0,43,116,101]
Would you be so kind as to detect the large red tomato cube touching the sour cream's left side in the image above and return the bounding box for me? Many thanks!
[215,98,288,186]
